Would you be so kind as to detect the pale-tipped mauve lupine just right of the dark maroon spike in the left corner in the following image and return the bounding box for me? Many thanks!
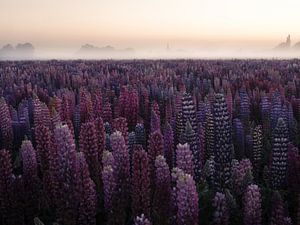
[21,140,40,221]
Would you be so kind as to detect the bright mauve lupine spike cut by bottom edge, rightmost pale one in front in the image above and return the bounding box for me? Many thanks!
[243,184,261,225]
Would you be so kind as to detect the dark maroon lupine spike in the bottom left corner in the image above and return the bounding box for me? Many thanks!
[0,149,24,225]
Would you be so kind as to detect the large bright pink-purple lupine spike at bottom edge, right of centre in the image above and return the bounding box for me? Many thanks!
[176,173,199,225]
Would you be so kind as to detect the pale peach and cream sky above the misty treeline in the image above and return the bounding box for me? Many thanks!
[0,0,300,48]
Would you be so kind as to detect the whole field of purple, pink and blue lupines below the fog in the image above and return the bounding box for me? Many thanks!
[0,60,300,225]
